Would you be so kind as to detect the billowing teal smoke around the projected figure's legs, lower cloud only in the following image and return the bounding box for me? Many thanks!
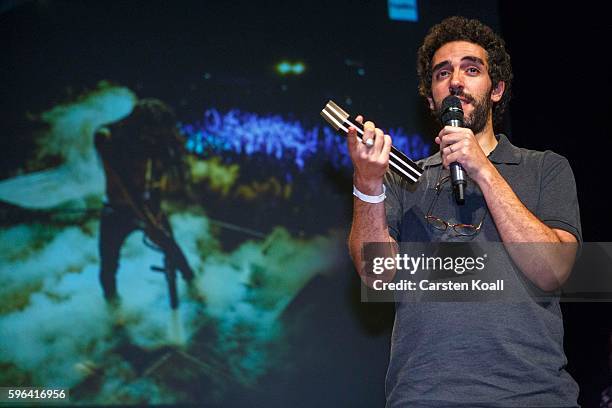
[0,213,333,403]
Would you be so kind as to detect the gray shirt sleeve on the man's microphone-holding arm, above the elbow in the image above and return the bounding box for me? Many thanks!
[536,151,582,243]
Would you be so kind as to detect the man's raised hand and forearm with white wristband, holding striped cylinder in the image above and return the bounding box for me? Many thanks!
[347,116,397,286]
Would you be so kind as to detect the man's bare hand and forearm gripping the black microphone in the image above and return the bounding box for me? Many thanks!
[436,126,578,291]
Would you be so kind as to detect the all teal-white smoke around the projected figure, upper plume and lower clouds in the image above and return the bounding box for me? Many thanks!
[0,85,340,404]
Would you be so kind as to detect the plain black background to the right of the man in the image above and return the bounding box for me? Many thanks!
[500,1,612,407]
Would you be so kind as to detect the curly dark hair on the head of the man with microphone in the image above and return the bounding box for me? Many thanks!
[417,16,513,123]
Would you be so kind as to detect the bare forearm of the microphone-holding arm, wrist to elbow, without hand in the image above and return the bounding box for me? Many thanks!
[478,165,577,291]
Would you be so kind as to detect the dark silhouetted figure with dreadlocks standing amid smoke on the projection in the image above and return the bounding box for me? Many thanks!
[95,99,194,303]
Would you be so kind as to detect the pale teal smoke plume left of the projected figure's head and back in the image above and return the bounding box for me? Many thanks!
[0,82,136,209]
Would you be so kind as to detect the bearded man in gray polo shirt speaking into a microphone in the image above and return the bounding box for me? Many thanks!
[348,17,582,407]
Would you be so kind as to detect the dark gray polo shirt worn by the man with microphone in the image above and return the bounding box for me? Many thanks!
[385,135,582,408]
